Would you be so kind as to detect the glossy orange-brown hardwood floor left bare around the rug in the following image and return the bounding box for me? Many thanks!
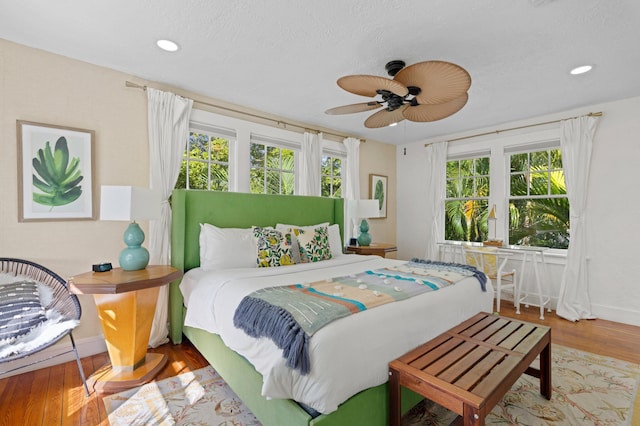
[0,302,640,426]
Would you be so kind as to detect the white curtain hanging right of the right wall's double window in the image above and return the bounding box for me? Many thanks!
[556,116,598,321]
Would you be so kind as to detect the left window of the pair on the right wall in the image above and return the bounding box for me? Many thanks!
[445,156,489,241]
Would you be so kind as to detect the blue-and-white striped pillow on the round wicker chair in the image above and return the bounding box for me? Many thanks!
[0,281,46,341]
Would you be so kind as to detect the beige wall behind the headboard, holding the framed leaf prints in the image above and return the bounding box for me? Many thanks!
[0,39,395,352]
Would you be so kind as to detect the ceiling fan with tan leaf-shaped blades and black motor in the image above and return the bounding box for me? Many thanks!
[325,60,471,128]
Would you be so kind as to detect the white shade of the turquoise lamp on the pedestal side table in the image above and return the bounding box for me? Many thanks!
[100,185,160,221]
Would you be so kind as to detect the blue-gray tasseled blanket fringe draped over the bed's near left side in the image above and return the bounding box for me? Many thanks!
[233,296,311,375]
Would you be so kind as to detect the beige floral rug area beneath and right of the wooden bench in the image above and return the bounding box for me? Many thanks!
[402,345,640,426]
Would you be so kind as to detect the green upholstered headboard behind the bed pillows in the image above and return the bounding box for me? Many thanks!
[169,189,344,343]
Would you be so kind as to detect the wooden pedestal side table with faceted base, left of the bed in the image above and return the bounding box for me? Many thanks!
[68,265,182,393]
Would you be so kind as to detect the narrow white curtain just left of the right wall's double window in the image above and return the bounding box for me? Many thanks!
[425,141,449,260]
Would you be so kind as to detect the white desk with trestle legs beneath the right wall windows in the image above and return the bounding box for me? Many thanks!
[438,241,551,319]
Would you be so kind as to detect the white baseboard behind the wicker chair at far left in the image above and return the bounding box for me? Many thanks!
[0,335,107,379]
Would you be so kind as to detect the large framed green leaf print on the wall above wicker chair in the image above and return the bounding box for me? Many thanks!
[16,120,97,222]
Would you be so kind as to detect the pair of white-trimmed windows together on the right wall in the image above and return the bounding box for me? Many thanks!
[444,134,569,251]
